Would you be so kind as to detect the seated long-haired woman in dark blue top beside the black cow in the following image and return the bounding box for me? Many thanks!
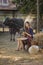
[17,21,33,50]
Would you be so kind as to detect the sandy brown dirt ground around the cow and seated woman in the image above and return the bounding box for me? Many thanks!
[0,33,43,65]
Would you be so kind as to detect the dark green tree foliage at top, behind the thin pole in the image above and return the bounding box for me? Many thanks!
[13,0,43,14]
